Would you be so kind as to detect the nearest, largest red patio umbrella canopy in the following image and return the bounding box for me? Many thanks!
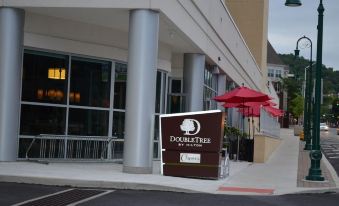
[213,86,271,103]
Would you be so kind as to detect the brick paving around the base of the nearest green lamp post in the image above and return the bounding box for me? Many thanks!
[297,141,335,188]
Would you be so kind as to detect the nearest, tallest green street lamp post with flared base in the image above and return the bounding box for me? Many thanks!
[285,0,325,181]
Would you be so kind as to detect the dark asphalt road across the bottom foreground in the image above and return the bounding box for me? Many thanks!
[0,183,339,206]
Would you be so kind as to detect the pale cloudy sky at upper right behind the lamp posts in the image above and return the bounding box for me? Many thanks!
[268,0,339,70]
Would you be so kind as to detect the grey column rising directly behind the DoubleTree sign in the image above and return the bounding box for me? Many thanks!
[184,54,205,112]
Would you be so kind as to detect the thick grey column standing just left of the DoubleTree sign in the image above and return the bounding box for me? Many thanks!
[123,9,159,173]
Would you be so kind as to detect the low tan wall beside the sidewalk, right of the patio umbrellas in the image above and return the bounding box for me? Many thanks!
[253,135,281,163]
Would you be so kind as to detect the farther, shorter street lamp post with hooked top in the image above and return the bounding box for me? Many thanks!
[294,36,313,150]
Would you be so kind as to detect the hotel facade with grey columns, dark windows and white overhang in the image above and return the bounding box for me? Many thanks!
[0,0,266,173]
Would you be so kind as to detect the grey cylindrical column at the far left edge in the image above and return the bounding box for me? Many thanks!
[0,7,25,161]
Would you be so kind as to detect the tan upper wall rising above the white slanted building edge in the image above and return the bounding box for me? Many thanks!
[225,0,268,90]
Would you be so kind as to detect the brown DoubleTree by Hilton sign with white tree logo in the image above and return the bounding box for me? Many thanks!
[160,110,224,179]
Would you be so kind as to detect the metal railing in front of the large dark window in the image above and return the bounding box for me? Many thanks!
[25,134,120,160]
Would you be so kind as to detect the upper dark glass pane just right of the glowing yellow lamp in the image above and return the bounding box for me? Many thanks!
[69,57,111,108]
